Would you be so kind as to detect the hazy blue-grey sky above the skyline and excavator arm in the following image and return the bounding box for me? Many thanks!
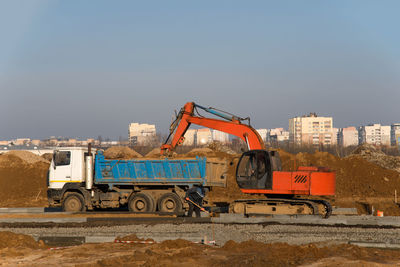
[0,0,400,140]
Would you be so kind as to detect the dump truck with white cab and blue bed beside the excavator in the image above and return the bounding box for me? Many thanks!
[47,146,228,213]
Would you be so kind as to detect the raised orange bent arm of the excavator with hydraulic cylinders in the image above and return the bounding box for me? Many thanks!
[161,102,265,154]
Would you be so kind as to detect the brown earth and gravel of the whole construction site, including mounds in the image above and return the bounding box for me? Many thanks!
[0,147,400,266]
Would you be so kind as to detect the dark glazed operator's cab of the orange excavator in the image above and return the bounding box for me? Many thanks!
[236,150,282,189]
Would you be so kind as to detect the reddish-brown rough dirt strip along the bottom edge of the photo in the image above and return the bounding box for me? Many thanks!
[14,239,400,267]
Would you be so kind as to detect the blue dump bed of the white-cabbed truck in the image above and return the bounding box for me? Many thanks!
[94,151,212,186]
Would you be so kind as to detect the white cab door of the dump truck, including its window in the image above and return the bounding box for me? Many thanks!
[50,151,72,183]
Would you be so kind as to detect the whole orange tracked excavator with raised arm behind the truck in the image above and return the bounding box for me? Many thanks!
[161,102,336,218]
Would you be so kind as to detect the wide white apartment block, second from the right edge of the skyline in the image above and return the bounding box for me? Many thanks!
[358,123,390,146]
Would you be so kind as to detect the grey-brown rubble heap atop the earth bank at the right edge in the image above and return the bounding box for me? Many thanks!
[349,144,400,172]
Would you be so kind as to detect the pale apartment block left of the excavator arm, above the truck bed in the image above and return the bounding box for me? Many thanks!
[129,122,156,145]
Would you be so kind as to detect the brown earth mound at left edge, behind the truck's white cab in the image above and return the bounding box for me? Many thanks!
[0,151,49,207]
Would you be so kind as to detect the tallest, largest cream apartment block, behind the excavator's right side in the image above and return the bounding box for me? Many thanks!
[289,113,333,145]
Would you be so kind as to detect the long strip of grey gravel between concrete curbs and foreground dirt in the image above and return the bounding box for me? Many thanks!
[1,224,400,245]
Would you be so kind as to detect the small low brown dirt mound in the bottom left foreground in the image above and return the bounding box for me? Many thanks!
[0,231,44,249]
